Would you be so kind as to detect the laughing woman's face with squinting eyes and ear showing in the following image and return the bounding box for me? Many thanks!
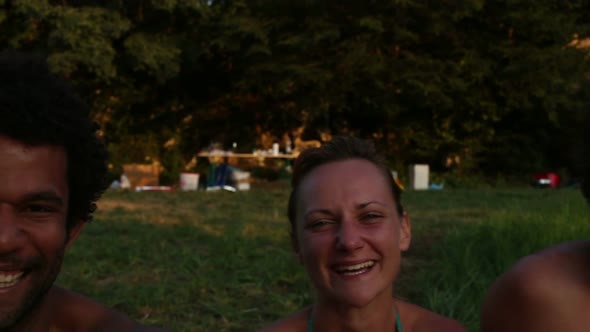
[296,159,411,307]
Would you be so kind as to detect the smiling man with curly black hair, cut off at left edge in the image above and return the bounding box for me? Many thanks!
[0,54,163,332]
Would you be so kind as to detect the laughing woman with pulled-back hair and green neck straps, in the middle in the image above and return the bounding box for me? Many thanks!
[265,137,466,332]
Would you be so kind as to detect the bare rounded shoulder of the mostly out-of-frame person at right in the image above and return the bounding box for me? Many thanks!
[481,241,590,332]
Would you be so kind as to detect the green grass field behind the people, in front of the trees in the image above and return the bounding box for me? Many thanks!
[58,185,590,332]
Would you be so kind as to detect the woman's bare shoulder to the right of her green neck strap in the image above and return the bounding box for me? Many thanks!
[395,300,467,332]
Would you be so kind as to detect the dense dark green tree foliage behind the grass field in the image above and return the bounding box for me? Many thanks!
[0,0,590,182]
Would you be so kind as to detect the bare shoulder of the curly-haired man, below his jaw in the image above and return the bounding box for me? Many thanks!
[48,287,168,332]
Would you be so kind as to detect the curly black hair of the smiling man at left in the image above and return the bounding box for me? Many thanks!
[0,52,107,229]
